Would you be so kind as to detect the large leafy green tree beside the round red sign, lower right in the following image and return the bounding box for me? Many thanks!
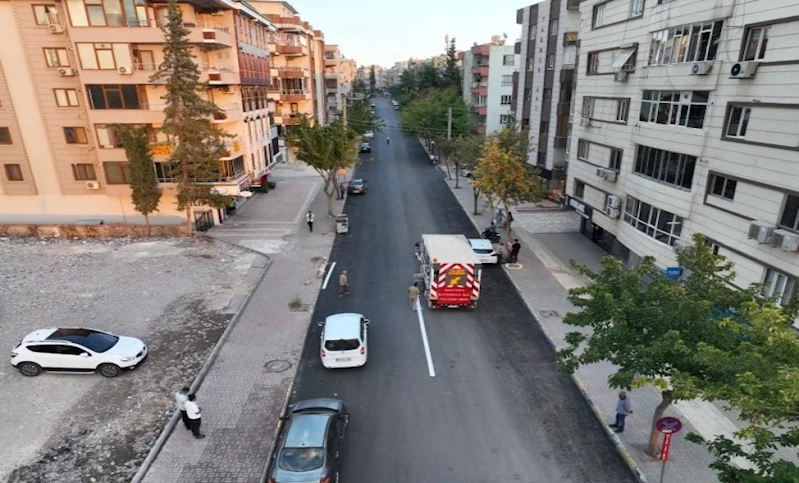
[559,234,799,476]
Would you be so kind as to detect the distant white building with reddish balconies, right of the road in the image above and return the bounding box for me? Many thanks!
[460,35,519,134]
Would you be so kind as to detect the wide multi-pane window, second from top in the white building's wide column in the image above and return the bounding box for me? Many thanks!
[639,91,710,129]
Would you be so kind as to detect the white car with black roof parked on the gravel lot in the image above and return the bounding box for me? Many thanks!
[11,328,147,377]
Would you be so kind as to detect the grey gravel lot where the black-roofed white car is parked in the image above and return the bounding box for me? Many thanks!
[0,238,263,483]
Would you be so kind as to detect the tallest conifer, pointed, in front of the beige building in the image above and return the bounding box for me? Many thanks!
[150,0,230,233]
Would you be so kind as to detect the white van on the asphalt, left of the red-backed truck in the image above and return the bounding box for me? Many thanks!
[319,313,369,369]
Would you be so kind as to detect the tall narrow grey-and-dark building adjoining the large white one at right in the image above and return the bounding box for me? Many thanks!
[514,0,580,199]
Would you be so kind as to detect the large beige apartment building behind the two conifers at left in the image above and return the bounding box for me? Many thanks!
[0,0,277,223]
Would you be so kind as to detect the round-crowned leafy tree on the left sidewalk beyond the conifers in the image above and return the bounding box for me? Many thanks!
[288,116,360,216]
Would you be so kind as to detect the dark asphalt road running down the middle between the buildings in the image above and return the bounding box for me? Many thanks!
[292,100,635,483]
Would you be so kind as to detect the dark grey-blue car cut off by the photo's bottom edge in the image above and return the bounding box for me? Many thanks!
[268,398,349,483]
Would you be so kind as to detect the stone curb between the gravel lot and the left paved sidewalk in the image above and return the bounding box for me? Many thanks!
[131,255,272,483]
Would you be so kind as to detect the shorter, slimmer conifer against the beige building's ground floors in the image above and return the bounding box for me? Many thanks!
[114,125,161,235]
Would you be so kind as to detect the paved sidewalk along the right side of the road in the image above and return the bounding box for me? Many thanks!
[428,153,720,483]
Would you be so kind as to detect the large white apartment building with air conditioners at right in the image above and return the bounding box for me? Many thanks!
[567,0,799,310]
